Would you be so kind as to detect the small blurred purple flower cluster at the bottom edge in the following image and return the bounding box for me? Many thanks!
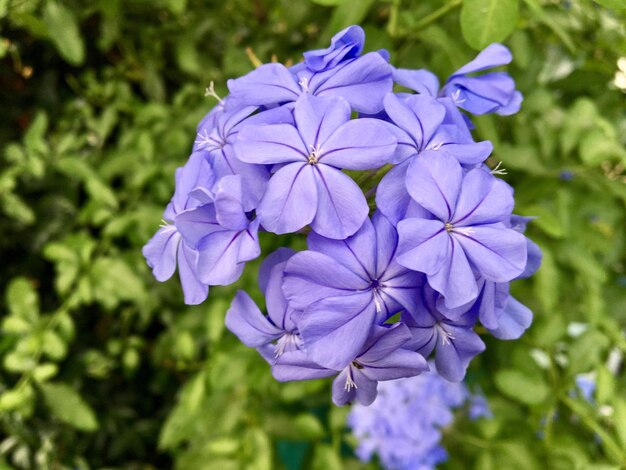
[348,368,491,470]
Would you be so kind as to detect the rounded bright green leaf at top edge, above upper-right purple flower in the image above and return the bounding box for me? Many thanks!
[461,0,519,50]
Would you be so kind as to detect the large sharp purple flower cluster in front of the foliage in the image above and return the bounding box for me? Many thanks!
[143,26,540,405]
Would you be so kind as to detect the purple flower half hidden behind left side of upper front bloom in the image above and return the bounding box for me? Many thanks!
[194,106,293,211]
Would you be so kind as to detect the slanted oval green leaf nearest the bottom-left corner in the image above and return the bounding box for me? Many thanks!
[40,383,98,432]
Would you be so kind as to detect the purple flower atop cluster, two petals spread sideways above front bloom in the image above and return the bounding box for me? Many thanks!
[228,50,393,114]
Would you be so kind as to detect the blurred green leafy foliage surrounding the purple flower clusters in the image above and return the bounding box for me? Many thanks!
[0,0,626,470]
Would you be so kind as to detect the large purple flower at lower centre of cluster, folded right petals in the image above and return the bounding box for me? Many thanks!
[283,212,423,370]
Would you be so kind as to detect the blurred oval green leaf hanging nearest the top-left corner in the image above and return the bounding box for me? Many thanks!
[43,0,85,65]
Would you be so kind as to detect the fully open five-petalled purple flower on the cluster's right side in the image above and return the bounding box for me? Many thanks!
[398,155,527,308]
